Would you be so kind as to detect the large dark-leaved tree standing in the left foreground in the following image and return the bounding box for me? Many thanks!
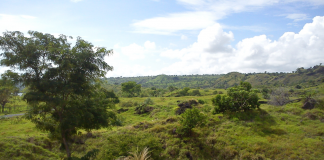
[0,31,114,158]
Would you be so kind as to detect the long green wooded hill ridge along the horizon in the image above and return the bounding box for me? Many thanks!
[105,65,324,89]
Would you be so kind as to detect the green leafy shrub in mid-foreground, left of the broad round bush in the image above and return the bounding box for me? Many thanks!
[177,107,207,135]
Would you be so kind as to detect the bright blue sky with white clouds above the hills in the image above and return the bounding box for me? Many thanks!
[0,0,324,77]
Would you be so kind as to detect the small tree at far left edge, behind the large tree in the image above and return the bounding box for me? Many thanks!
[0,71,19,113]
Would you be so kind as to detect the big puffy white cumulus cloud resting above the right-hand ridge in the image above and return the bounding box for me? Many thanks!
[161,16,324,74]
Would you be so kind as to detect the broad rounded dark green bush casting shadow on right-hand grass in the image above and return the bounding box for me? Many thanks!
[212,82,260,114]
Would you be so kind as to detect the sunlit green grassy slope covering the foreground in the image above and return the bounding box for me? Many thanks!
[0,85,324,159]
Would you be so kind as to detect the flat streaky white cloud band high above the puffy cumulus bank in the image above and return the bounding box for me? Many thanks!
[132,0,324,35]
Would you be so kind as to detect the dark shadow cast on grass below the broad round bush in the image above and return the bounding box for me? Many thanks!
[224,109,286,136]
